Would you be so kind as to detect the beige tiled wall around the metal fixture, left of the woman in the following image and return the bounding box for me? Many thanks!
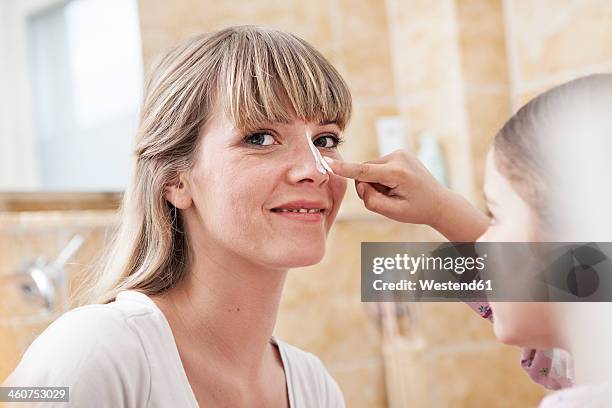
[0,211,115,381]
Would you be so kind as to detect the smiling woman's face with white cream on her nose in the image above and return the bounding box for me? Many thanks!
[179,108,346,269]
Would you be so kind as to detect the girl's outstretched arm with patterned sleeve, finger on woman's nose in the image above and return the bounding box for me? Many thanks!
[328,150,573,389]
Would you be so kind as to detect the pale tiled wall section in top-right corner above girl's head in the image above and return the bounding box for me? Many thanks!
[504,0,612,109]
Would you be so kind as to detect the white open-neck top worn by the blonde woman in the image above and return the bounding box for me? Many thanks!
[4,291,344,408]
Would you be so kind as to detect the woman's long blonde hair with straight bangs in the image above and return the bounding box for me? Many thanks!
[81,26,351,303]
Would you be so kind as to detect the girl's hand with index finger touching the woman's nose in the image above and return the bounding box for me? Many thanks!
[325,150,489,242]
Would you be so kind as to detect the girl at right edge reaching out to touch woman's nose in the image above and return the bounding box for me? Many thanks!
[328,74,612,408]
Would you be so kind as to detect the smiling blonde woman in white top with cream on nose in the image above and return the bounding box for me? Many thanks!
[8,26,351,407]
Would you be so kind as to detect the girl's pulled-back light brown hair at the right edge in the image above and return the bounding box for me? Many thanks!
[493,74,612,232]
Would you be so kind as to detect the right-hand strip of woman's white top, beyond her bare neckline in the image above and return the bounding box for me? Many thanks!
[274,339,344,408]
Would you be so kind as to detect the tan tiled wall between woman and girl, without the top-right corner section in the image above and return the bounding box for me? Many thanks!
[133,0,542,407]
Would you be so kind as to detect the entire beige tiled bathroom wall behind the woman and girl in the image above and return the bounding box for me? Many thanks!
[0,0,612,407]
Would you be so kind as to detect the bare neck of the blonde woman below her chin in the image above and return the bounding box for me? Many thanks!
[153,241,287,374]
